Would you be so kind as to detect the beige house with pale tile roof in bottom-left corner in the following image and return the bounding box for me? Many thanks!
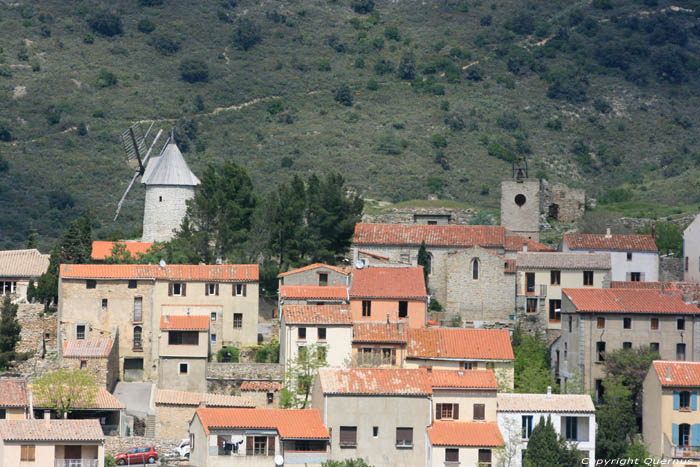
[0,419,104,467]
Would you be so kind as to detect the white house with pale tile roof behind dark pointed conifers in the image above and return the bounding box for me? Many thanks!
[498,388,596,467]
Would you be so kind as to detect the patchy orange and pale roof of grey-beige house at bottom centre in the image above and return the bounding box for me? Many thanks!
[318,368,432,396]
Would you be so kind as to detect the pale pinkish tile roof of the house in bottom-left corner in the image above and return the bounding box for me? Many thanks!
[0,418,105,442]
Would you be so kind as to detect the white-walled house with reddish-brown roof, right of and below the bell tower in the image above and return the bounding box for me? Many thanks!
[561,228,659,282]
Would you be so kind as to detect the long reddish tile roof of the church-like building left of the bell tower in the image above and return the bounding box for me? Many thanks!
[353,223,506,247]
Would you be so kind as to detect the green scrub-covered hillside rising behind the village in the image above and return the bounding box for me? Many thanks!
[0,0,700,249]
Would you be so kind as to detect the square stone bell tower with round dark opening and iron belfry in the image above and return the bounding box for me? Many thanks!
[501,160,541,241]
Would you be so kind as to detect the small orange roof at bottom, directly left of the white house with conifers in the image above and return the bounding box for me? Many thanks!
[428,421,503,447]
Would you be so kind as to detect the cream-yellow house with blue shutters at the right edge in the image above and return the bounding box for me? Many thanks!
[642,360,700,466]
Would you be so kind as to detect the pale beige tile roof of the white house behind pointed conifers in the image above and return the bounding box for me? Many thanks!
[498,393,595,412]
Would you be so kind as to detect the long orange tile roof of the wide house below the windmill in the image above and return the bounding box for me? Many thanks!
[61,264,259,282]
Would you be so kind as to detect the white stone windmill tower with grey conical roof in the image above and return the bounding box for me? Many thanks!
[141,137,199,242]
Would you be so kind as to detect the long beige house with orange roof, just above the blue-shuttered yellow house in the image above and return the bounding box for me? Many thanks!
[552,289,700,398]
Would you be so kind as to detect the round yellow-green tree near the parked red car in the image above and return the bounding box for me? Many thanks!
[32,368,99,418]
